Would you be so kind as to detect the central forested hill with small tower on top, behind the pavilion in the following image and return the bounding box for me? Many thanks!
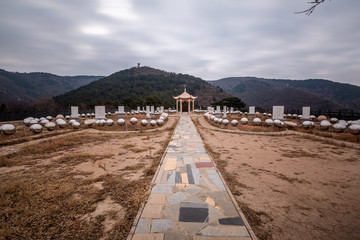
[54,67,231,108]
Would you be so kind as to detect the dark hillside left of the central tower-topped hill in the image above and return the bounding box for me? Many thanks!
[0,69,101,105]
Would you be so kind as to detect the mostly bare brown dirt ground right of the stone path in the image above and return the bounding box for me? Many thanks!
[194,117,360,239]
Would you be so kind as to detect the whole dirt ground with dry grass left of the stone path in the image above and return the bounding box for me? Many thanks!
[0,117,177,239]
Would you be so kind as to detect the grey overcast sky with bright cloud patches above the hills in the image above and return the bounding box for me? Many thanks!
[0,0,360,86]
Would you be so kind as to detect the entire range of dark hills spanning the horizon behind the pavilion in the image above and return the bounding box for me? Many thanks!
[0,67,360,111]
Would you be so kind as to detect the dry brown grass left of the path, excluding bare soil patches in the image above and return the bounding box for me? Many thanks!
[0,116,177,239]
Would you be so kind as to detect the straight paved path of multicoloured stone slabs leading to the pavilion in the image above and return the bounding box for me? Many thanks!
[132,115,253,240]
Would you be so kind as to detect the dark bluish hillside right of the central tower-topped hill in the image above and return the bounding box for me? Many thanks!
[209,77,360,111]
